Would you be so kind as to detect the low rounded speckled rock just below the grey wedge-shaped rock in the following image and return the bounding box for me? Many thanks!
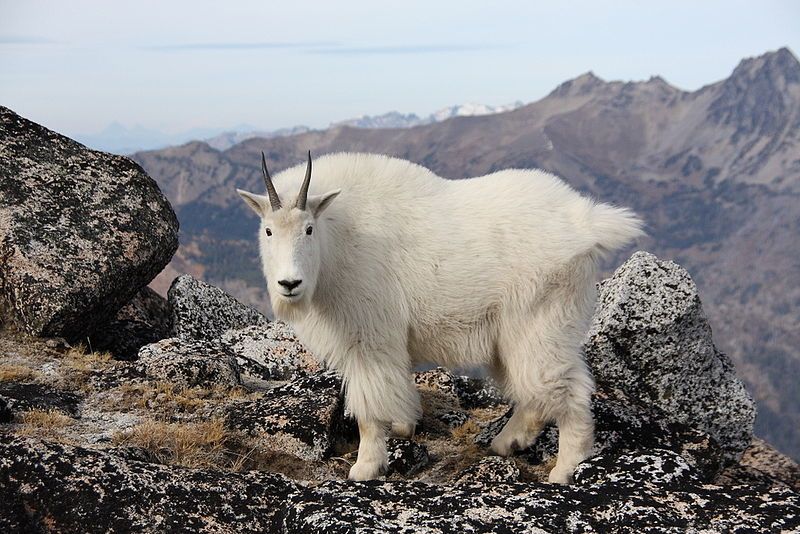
[137,338,241,387]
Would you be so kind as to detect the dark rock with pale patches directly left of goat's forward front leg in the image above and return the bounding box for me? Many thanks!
[225,372,353,460]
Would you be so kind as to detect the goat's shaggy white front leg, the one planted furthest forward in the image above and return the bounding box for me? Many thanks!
[344,351,422,480]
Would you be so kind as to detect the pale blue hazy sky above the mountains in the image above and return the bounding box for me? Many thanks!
[0,0,800,135]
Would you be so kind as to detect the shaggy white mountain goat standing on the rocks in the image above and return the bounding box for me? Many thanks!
[238,153,642,483]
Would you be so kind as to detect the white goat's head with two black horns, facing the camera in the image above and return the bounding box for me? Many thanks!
[237,151,340,311]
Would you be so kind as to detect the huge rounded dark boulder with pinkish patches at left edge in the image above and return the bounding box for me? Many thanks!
[0,107,178,339]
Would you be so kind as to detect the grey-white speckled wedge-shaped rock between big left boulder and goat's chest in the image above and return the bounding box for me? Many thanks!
[167,274,269,340]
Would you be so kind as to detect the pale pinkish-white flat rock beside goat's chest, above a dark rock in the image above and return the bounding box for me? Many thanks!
[221,321,322,380]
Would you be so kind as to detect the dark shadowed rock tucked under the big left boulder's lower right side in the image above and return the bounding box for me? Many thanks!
[90,287,172,360]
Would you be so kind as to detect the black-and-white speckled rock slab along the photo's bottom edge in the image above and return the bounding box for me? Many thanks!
[0,435,800,534]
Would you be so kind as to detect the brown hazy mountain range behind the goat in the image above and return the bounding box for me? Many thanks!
[133,48,800,458]
